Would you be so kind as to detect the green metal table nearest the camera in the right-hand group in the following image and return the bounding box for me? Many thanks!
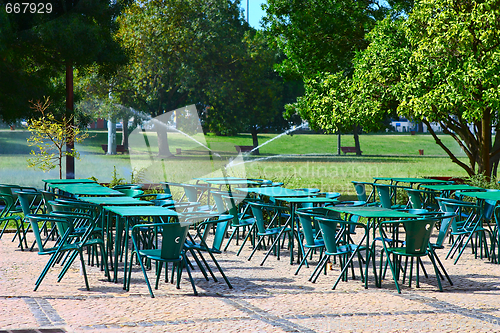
[325,206,420,289]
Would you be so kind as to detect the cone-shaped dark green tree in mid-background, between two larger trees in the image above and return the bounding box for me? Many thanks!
[202,29,295,154]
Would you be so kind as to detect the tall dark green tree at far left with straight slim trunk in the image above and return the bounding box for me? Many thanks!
[0,0,126,178]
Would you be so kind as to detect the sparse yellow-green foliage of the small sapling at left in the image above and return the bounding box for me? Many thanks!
[27,98,88,179]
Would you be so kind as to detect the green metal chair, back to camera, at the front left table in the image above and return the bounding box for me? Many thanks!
[127,222,198,297]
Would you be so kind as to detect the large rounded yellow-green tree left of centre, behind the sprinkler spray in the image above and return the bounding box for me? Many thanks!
[112,0,245,156]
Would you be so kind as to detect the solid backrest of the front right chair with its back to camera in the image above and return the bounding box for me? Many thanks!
[403,218,437,255]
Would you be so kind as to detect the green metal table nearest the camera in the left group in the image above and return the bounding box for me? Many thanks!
[104,206,181,289]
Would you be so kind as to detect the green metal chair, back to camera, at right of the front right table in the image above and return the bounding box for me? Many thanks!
[379,218,443,293]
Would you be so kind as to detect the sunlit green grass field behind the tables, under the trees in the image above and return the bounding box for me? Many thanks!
[0,130,466,195]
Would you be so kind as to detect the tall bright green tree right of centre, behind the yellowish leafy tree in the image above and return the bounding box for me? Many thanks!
[264,0,413,154]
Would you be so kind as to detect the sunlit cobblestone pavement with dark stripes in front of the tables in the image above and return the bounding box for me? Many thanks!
[0,234,500,333]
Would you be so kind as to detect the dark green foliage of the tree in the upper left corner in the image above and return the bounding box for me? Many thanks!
[0,0,126,121]
